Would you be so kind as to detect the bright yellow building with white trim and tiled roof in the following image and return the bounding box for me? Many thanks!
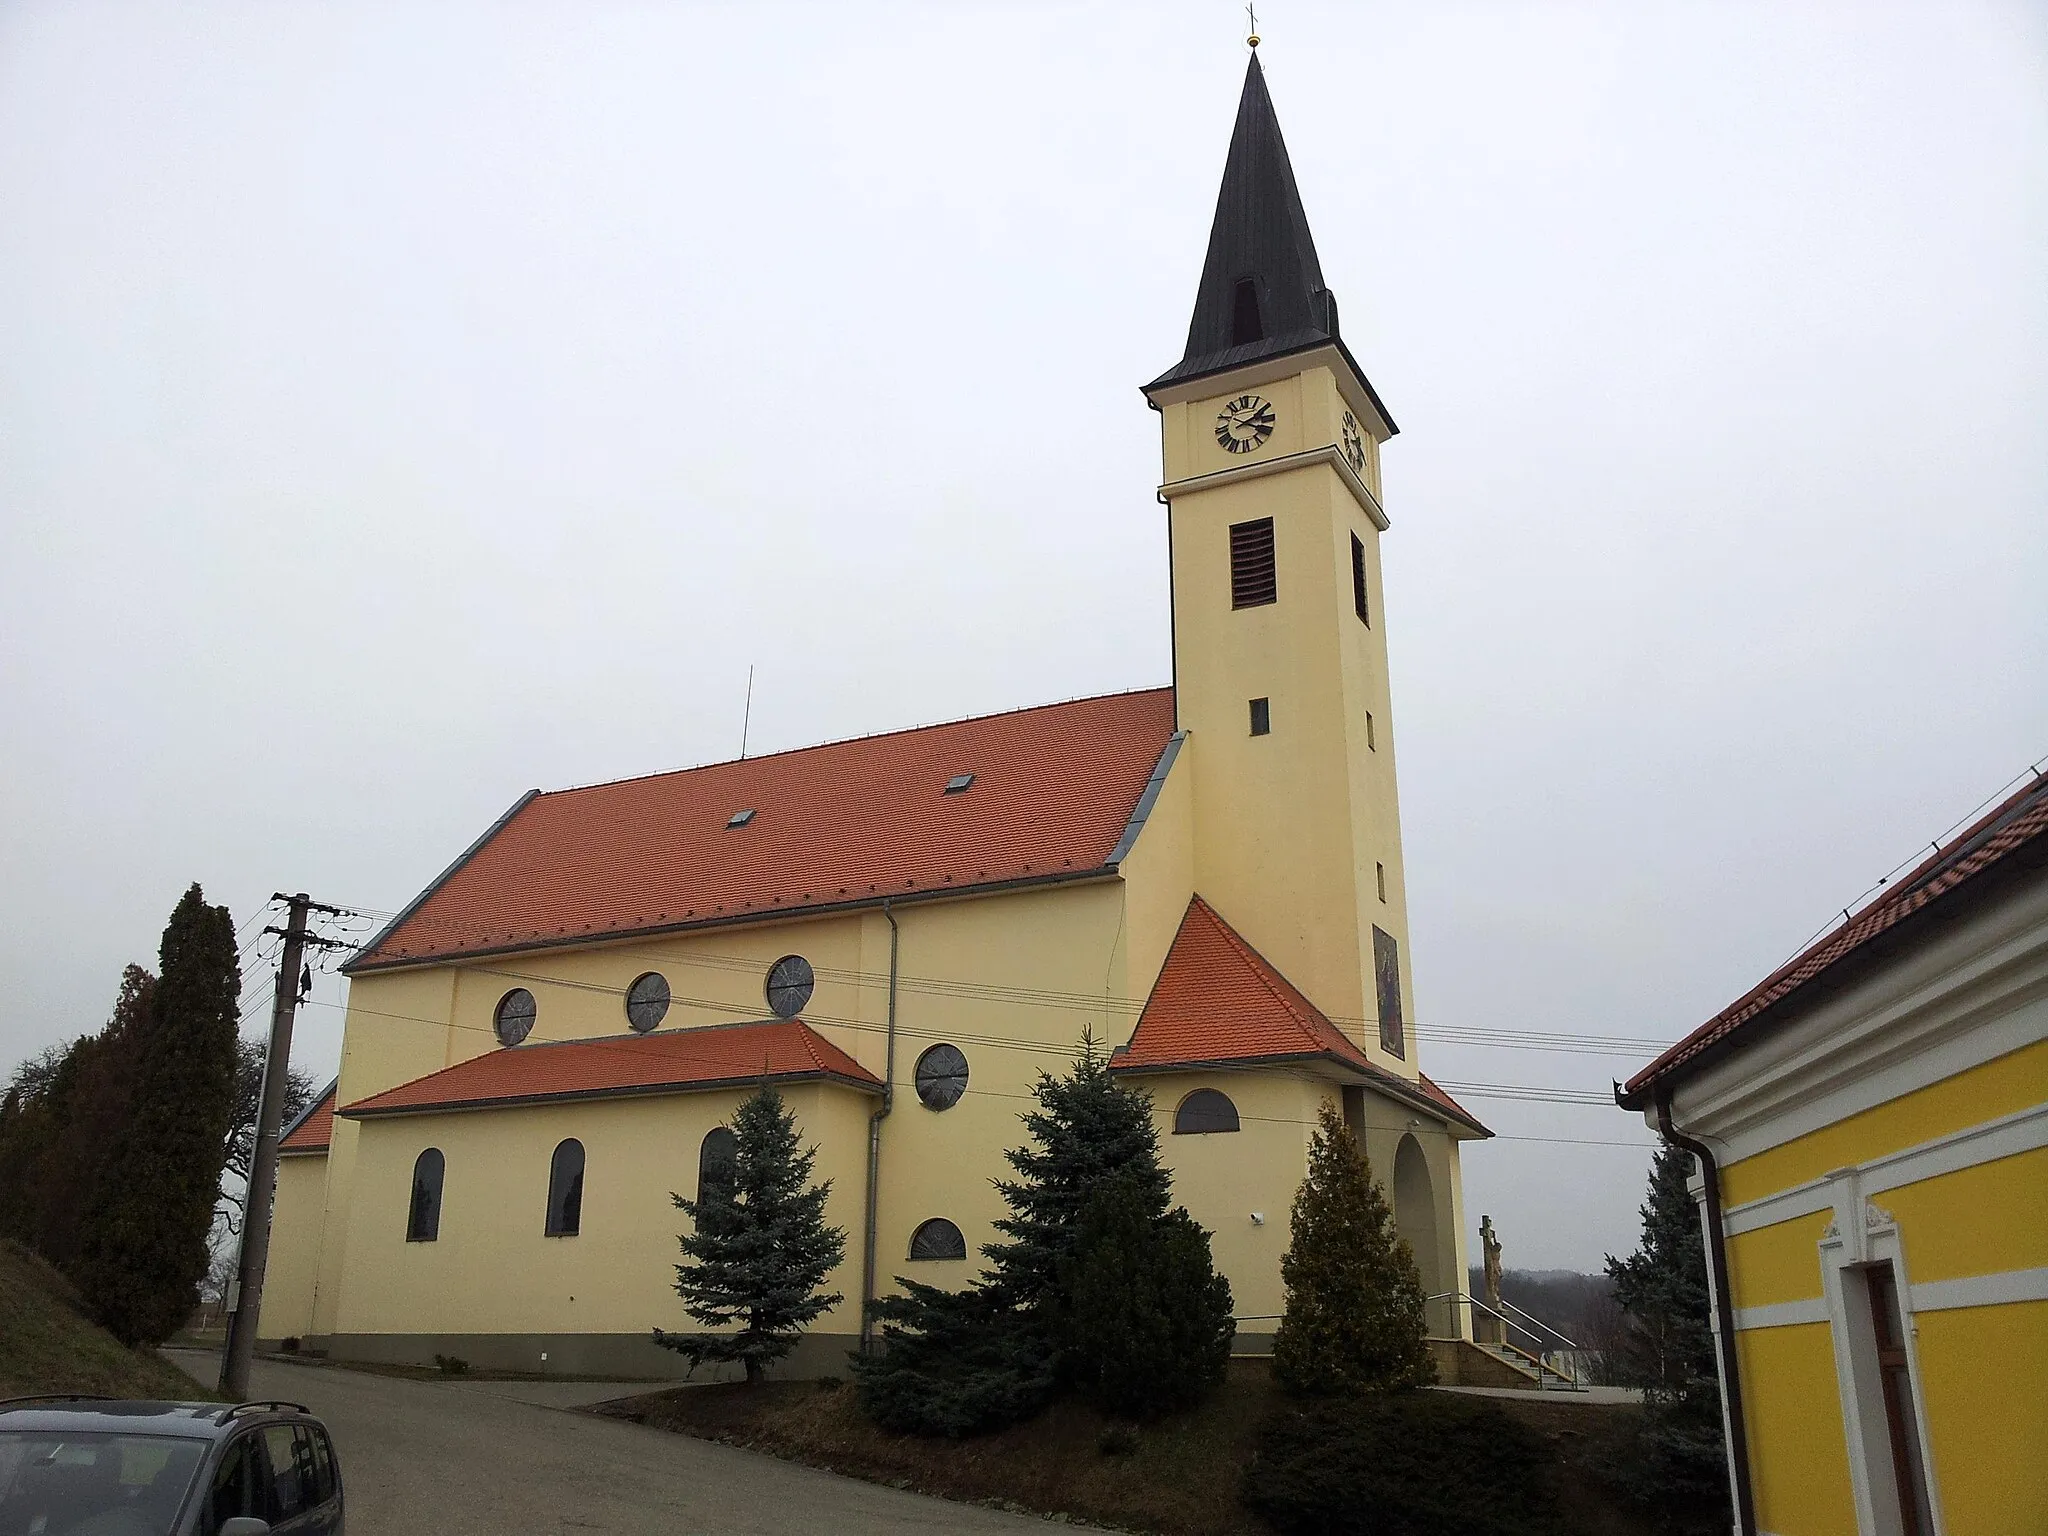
[1624,776,2048,1536]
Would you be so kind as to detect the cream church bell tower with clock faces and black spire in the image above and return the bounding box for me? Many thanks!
[1145,53,1417,1079]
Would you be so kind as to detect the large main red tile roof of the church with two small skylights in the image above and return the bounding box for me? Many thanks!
[346,688,1174,971]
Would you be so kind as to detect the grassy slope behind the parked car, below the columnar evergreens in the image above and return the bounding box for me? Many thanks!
[0,1241,213,1403]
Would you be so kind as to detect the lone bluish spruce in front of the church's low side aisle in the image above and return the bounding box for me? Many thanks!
[653,1087,846,1382]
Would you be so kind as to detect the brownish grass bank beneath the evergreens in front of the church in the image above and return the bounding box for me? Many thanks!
[598,1360,1661,1536]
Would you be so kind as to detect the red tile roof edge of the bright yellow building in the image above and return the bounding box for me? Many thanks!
[1620,774,2048,1110]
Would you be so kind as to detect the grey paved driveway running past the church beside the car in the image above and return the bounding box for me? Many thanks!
[172,1352,1073,1536]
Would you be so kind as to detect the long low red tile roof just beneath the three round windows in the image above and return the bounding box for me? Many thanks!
[340,1018,883,1120]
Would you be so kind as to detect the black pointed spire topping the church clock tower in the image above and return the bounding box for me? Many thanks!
[1145,53,1393,426]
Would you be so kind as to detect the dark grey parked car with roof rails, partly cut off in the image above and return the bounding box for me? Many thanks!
[0,1397,342,1536]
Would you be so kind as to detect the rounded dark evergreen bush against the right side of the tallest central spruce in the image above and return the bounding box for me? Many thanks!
[1053,1176,1237,1419]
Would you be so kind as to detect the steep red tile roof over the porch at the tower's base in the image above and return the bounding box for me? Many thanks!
[1110,897,1491,1137]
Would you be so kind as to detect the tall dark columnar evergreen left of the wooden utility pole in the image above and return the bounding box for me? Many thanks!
[78,885,242,1343]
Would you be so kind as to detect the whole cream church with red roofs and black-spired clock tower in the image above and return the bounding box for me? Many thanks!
[260,55,1487,1376]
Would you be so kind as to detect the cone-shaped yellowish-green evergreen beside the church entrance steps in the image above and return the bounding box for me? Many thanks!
[1274,1102,1436,1395]
